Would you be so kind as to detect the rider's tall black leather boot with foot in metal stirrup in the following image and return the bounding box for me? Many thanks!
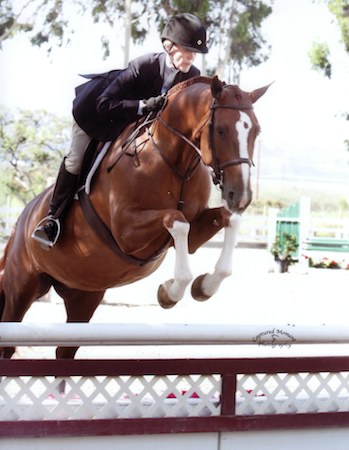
[32,161,78,247]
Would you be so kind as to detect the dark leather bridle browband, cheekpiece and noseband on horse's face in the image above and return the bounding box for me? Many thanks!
[209,103,254,189]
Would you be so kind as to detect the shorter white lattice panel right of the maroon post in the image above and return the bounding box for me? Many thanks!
[236,372,349,415]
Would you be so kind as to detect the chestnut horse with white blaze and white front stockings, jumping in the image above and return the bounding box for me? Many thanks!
[0,77,268,358]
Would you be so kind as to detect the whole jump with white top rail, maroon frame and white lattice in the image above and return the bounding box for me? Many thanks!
[0,323,349,450]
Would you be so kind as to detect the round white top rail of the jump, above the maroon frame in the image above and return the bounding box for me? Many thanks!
[0,322,349,346]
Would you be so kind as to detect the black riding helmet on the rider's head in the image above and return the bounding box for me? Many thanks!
[161,13,208,53]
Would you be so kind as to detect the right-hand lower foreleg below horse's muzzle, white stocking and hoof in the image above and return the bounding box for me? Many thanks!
[191,214,241,301]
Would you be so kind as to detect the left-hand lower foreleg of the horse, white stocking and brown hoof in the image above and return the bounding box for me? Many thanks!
[158,220,193,309]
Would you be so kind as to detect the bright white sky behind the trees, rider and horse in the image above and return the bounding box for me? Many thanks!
[0,0,349,186]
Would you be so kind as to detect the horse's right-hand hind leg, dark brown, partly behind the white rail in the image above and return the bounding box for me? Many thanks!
[54,285,105,358]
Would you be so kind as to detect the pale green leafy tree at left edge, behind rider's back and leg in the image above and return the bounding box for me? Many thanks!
[0,110,71,204]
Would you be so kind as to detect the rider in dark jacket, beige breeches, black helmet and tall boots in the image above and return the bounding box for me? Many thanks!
[32,13,208,247]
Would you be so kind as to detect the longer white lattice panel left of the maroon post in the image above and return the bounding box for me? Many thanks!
[0,375,221,420]
